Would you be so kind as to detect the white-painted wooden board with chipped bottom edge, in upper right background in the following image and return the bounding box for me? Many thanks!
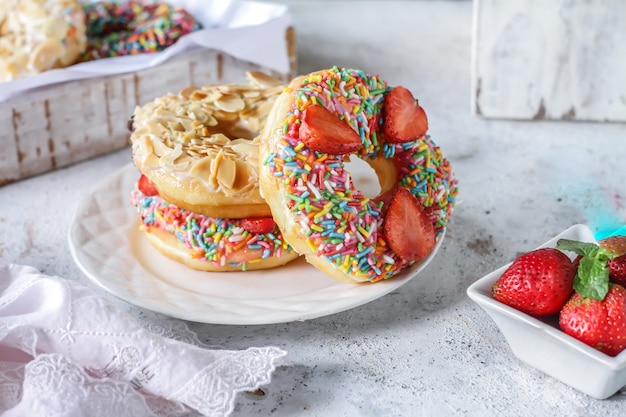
[472,0,626,122]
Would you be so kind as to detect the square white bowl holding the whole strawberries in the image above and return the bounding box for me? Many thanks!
[467,224,626,399]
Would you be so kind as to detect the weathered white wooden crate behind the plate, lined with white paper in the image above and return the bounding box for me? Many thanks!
[0,28,296,185]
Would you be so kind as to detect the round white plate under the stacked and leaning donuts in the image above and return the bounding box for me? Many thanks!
[69,165,443,324]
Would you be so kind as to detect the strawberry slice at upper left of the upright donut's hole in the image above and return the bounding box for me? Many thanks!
[299,104,361,155]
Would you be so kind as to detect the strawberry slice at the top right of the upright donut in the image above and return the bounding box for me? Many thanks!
[383,86,428,143]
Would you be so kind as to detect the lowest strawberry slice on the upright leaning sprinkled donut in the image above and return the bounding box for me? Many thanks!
[383,187,436,261]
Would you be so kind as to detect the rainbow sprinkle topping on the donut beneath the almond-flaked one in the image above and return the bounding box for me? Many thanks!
[131,189,292,271]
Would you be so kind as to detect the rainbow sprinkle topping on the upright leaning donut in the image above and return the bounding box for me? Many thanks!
[262,67,458,282]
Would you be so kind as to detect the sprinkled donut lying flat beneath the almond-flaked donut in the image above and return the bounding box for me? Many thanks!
[131,184,298,272]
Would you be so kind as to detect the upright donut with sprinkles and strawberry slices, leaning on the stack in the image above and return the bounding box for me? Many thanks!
[259,67,458,283]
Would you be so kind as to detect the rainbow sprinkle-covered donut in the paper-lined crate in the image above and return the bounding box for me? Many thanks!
[81,0,202,61]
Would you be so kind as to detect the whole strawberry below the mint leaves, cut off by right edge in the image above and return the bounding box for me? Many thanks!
[559,284,626,356]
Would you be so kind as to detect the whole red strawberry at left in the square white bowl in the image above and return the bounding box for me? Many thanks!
[492,248,576,317]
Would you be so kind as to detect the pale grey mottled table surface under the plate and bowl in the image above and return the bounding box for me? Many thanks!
[0,0,626,416]
